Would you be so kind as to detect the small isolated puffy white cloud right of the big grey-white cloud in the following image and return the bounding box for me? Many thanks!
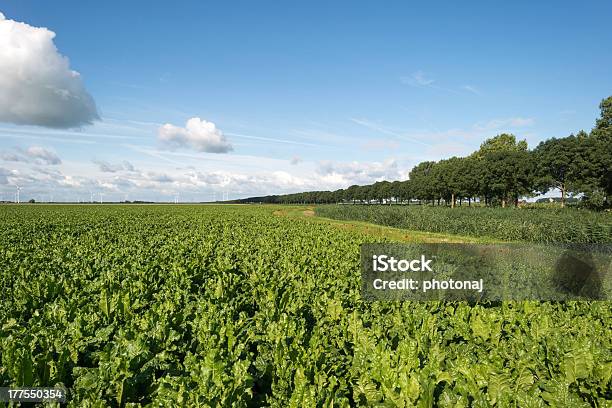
[159,118,233,153]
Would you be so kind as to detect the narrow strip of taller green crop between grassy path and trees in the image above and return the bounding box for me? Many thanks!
[316,205,612,243]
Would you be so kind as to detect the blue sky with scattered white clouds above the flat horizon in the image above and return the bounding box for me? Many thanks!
[0,0,612,202]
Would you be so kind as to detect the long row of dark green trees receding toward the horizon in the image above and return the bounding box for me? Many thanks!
[240,96,612,208]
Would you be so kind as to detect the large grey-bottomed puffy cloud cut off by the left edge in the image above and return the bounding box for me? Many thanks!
[0,13,99,128]
